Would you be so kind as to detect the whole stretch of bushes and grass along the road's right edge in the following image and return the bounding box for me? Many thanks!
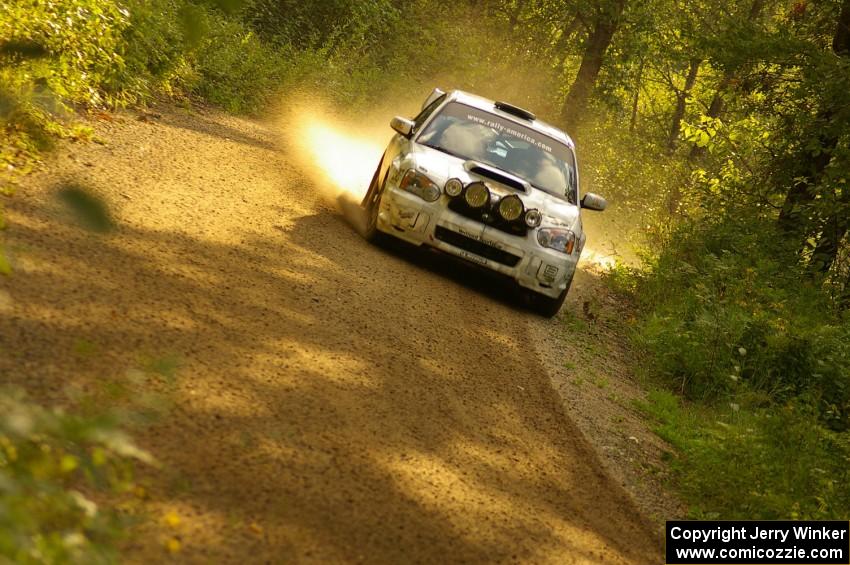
[604,218,850,519]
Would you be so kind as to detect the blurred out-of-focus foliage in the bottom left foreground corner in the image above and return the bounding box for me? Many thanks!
[0,390,152,563]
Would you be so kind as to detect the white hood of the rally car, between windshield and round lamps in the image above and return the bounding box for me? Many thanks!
[405,143,580,231]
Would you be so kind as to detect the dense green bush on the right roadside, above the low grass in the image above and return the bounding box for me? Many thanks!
[635,216,850,430]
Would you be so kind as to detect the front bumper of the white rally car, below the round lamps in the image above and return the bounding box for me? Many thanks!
[377,185,578,298]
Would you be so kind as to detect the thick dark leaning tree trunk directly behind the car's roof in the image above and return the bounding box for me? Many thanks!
[561,0,625,128]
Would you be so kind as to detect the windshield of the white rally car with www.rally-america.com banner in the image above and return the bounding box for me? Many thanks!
[416,102,577,204]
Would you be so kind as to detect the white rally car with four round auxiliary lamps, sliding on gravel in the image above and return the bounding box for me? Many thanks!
[362,89,606,316]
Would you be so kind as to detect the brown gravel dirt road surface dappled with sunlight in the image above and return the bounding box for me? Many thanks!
[0,104,661,563]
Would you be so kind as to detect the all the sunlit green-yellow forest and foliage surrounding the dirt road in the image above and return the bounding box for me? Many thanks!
[0,0,850,562]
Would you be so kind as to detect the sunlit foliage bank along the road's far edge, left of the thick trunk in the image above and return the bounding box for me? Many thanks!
[0,0,558,145]
